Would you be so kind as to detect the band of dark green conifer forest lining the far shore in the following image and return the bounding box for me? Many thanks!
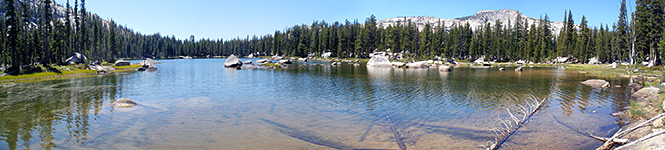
[0,0,665,71]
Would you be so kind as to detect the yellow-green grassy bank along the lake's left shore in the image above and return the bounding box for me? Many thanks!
[0,64,141,83]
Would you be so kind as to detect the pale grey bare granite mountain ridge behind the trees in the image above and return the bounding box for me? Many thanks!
[377,9,564,35]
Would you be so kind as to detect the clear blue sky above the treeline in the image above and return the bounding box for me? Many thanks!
[56,0,634,40]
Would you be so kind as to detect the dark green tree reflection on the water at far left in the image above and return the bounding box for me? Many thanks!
[0,76,122,149]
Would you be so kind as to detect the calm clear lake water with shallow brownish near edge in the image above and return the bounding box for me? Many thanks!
[0,59,630,149]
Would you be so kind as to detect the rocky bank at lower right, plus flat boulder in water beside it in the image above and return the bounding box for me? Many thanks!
[581,76,665,150]
